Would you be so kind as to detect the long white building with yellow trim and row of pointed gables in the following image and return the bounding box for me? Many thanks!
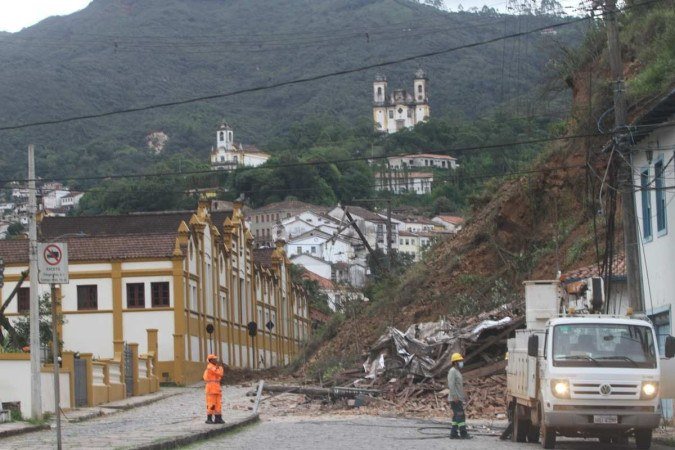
[0,201,310,384]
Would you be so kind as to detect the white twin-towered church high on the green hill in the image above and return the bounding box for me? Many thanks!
[373,69,430,134]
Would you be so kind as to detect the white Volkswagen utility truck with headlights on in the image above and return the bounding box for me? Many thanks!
[507,278,675,449]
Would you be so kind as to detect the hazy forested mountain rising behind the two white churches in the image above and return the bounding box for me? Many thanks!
[0,0,582,181]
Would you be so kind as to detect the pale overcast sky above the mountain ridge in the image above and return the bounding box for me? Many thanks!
[0,0,579,32]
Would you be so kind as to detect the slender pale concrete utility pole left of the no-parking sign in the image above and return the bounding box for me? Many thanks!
[28,144,42,420]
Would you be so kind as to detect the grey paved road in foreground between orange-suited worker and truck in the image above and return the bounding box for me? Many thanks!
[189,416,673,450]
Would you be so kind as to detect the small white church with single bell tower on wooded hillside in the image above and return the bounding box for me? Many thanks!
[211,123,270,170]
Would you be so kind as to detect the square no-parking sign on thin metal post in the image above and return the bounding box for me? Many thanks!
[38,243,68,450]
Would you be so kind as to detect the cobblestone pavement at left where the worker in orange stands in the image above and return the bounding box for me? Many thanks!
[0,386,251,449]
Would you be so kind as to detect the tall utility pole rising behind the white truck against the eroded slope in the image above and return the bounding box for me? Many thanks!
[604,0,645,311]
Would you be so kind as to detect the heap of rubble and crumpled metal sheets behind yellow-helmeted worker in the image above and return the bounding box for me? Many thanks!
[334,303,524,419]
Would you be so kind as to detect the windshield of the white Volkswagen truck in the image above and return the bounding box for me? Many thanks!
[553,323,656,368]
